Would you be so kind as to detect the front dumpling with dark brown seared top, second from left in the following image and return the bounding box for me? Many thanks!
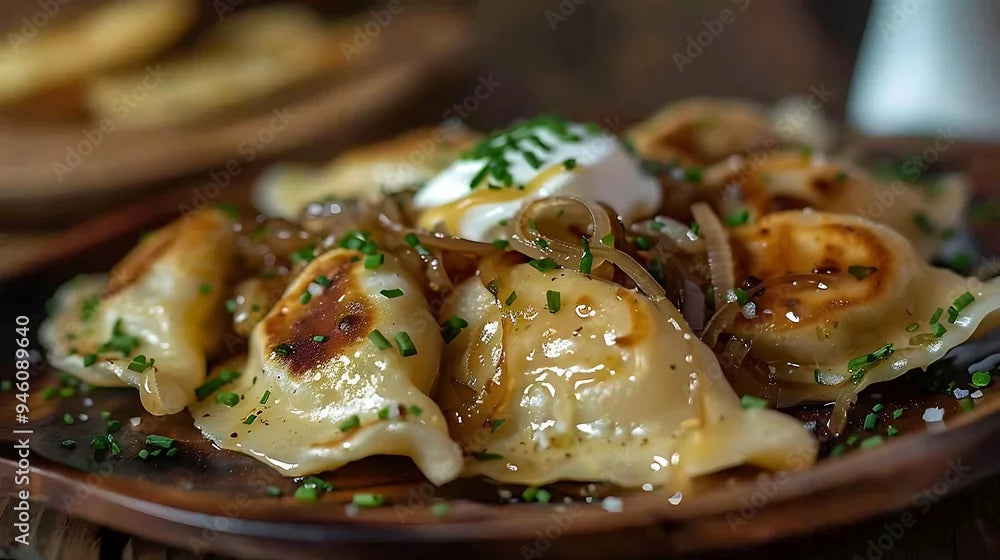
[191,249,462,484]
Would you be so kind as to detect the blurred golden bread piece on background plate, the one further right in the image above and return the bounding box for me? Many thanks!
[85,4,370,128]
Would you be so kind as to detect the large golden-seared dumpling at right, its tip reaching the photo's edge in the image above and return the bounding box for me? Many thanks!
[730,210,1000,422]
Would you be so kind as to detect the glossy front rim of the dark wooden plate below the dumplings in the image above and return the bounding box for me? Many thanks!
[7,394,1000,552]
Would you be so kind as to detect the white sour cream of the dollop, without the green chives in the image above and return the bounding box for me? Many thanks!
[414,124,660,241]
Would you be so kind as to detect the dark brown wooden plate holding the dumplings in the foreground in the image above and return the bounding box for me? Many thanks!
[0,143,1000,558]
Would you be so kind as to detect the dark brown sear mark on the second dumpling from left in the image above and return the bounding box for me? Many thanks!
[263,251,376,375]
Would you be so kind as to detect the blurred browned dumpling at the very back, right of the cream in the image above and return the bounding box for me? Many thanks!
[626,98,778,166]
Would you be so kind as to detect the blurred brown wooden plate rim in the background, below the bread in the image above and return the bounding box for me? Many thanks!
[0,8,469,219]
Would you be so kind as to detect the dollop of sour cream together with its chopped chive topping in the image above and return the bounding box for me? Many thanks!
[413,115,660,242]
